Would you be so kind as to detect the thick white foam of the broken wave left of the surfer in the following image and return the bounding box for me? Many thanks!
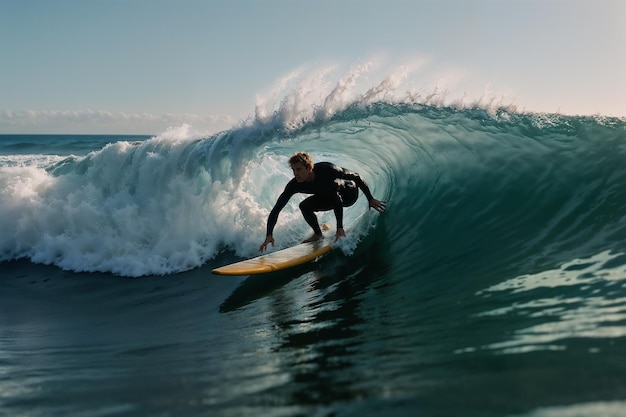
[0,117,378,276]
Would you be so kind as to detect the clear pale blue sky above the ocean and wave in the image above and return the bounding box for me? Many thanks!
[0,0,626,134]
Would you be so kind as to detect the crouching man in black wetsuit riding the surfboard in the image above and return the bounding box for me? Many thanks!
[259,152,386,252]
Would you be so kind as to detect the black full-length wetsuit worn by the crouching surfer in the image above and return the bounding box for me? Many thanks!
[267,162,374,236]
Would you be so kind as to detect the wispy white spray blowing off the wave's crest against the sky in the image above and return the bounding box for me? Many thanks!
[249,57,517,129]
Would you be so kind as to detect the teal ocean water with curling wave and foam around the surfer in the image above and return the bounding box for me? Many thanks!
[0,100,626,417]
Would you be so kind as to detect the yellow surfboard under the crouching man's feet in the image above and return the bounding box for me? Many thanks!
[213,236,335,275]
